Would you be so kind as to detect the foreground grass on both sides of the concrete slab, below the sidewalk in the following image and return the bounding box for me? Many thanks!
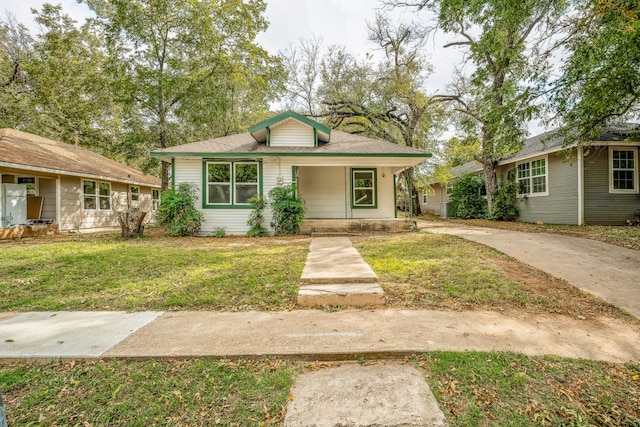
[0,352,640,427]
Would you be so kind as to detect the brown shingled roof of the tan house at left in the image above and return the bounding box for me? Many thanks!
[0,128,161,188]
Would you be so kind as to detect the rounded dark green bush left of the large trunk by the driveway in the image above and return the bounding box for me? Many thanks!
[448,174,487,219]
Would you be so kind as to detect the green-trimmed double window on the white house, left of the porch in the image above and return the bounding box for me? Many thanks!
[205,162,260,206]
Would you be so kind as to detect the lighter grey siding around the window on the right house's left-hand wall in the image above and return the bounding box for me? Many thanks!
[499,153,578,224]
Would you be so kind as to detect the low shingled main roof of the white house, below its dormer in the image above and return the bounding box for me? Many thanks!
[151,131,431,159]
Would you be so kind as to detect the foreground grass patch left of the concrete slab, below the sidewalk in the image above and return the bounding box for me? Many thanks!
[0,360,297,426]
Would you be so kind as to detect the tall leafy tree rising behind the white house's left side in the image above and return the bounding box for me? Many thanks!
[83,0,278,189]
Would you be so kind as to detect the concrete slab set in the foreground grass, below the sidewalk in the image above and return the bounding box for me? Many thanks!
[284,365,448,427]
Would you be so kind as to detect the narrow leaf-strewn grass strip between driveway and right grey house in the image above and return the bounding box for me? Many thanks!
[421,215,640,250]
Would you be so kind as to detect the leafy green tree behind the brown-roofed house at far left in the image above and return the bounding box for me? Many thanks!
[0,4,120,154]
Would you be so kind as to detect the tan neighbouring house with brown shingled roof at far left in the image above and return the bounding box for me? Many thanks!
[0,129,161,231]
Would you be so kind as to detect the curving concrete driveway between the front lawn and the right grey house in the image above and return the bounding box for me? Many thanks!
[418,221,640,319]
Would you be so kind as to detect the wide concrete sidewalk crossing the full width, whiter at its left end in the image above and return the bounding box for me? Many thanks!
[0,309,640,362]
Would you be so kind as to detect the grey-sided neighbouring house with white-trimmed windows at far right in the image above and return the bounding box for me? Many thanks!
[427,123,640,225]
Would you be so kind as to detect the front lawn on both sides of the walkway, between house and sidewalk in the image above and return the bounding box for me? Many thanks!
[0,229,622,317]
